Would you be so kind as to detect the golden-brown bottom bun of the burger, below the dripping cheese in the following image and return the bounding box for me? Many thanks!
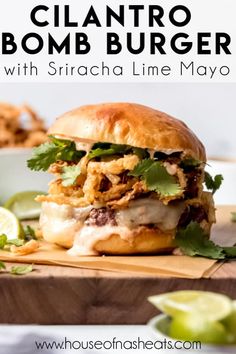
[94,227,175,255]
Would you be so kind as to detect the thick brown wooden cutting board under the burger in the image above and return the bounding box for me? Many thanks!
[0,206,236,324]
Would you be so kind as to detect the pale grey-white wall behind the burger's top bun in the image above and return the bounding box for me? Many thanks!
[0,83,236,158]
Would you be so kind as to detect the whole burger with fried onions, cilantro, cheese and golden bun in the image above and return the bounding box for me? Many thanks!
[28,103,219,255]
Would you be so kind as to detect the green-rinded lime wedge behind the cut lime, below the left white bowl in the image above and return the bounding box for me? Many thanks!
[4,191,45,220]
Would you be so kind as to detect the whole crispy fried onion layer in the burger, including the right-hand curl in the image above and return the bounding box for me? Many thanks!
[37,155,195,208]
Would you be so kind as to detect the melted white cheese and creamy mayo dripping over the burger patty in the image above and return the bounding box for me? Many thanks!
[40,198,184,256]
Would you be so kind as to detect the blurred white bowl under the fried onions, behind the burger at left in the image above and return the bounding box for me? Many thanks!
[0,148,50,204]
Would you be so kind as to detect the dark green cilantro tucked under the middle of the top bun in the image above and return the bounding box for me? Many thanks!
[88,143,149,159]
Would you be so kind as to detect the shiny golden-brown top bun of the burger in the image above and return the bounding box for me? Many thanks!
[48,103,206,161]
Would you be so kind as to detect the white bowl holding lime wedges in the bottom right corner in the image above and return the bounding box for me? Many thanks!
[148,314,236,354]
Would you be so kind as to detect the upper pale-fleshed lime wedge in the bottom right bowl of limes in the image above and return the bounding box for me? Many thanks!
[148,290,233,321]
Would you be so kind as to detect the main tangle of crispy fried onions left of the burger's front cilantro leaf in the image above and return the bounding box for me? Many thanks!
[36,155,146,207]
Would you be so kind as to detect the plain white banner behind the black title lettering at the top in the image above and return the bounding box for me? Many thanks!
[0,0,236,82]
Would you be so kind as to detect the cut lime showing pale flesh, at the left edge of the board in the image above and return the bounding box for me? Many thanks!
[0,207,24,240]
